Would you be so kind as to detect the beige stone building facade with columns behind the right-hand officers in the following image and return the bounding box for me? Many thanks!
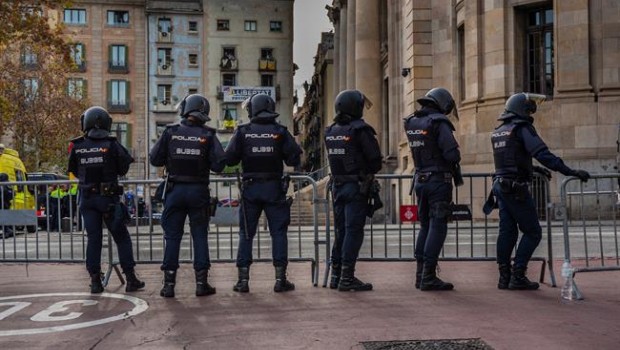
[328,0,620,216]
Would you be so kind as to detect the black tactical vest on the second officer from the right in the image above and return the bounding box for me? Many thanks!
[405,114,451,172]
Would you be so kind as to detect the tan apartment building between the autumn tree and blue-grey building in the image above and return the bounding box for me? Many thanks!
[57,0,146,177]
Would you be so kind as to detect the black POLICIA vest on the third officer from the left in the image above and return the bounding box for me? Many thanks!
[238,123,286,178]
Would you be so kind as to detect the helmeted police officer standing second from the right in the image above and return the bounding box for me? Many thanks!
[405,88,461,291]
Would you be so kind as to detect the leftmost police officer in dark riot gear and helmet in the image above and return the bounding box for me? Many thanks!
[68,106,144,293]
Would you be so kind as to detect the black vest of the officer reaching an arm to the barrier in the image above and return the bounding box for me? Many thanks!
[491,120,533,181]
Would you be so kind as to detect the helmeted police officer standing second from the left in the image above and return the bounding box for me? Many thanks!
[149,94,225,298]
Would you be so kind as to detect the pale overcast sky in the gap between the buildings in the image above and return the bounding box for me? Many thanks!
[293,0,333,103]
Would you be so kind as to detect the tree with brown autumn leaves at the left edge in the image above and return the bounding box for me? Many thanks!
[0,0,87,172]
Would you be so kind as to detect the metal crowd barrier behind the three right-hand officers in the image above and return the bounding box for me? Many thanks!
[323,173,556,287]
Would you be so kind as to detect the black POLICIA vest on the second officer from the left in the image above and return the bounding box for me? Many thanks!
[167,124,214,182]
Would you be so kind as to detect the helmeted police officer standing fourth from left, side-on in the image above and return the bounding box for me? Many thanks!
[325,90,382,291]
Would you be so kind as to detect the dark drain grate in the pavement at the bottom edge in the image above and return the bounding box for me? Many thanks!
[362,338,493,350]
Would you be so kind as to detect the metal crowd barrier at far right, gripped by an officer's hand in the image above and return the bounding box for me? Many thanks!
[557,174,620,300]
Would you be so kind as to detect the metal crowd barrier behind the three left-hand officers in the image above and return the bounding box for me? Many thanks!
[0,175,327,286]
